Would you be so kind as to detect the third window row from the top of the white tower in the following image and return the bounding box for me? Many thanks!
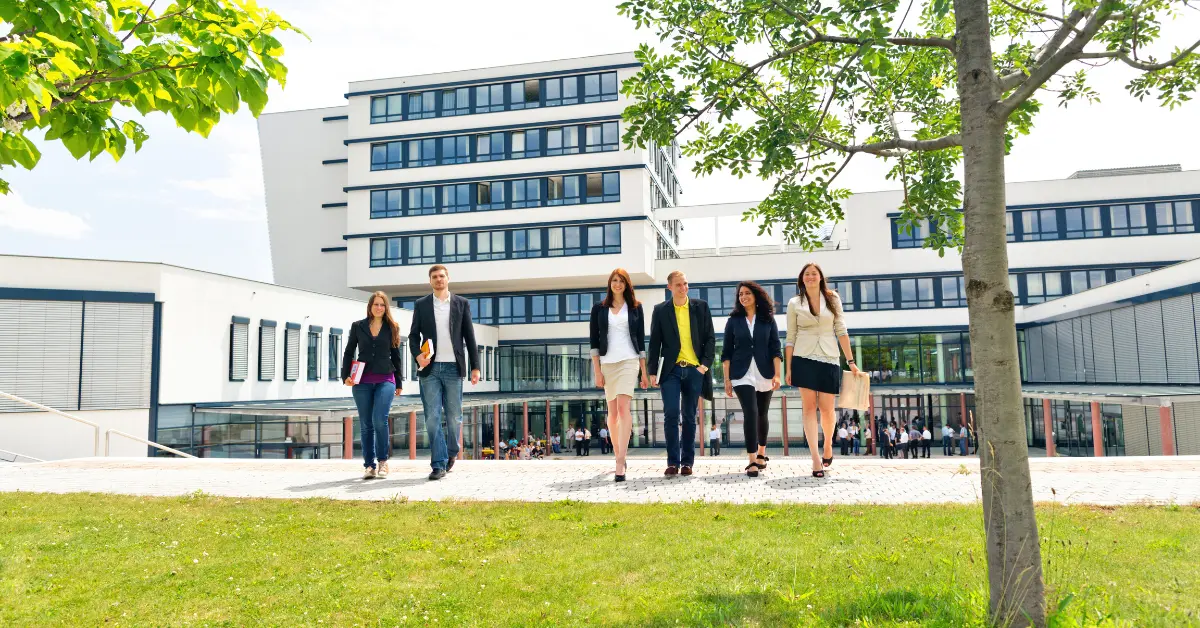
[371,172,620,219]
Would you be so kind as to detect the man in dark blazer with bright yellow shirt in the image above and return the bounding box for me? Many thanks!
[647,270,716,477]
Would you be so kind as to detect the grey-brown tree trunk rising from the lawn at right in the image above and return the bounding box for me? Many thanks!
[954,0,1045,627]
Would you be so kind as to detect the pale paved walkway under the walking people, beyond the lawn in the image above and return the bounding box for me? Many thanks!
[0,456,1200,506]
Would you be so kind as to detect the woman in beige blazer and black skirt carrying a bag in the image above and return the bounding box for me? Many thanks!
[785,262,858,478]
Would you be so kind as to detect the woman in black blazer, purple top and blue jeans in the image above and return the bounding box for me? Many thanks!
[342,292,404,479]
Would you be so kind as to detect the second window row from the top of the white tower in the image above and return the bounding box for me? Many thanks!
[371,121,620,171]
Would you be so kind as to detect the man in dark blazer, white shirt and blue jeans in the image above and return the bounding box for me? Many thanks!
[408,264,479,480]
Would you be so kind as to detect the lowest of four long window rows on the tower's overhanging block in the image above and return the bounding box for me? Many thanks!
[371,223,620,267]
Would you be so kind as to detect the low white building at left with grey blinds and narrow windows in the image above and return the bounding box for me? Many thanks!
[0,256,498,460]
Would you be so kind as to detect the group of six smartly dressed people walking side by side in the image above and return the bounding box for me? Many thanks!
[342,263,860,482]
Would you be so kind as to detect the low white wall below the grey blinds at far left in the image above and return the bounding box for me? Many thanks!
[0,409,150,460]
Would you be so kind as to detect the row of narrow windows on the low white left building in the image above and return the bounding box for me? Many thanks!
[229,321,342,382]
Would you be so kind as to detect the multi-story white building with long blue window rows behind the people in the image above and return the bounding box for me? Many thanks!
[259,54,1200,456]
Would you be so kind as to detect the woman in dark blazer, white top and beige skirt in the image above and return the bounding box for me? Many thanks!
[589,268,649,482]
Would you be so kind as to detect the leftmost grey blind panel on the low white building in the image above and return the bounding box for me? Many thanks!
[0,300,83,413]
